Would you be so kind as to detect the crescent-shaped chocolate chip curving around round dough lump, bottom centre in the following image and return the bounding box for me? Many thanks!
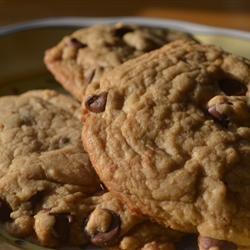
[86,210,121,247]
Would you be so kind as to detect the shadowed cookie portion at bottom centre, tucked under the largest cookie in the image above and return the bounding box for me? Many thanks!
[85,192,183,250]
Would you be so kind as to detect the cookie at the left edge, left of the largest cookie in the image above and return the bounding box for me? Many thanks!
[0,91,99,246]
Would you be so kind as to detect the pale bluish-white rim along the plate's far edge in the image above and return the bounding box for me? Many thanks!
[0,16,250,40]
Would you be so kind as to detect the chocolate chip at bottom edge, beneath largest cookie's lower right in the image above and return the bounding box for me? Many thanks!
[198,236,237,250]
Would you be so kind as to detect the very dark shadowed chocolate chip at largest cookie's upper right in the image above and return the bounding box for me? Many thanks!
[219,77,247,96]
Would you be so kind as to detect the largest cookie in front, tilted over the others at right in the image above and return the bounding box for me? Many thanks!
[83,40,250,250]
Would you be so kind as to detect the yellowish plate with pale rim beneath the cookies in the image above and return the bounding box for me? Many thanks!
[0,17,250,250]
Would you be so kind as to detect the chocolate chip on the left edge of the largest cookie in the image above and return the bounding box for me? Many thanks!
[85,92,108,113]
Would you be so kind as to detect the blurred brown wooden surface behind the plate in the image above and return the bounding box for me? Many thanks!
[0,0,250,31]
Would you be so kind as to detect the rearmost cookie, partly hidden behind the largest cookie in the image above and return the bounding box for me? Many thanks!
[44,23,194,101]
